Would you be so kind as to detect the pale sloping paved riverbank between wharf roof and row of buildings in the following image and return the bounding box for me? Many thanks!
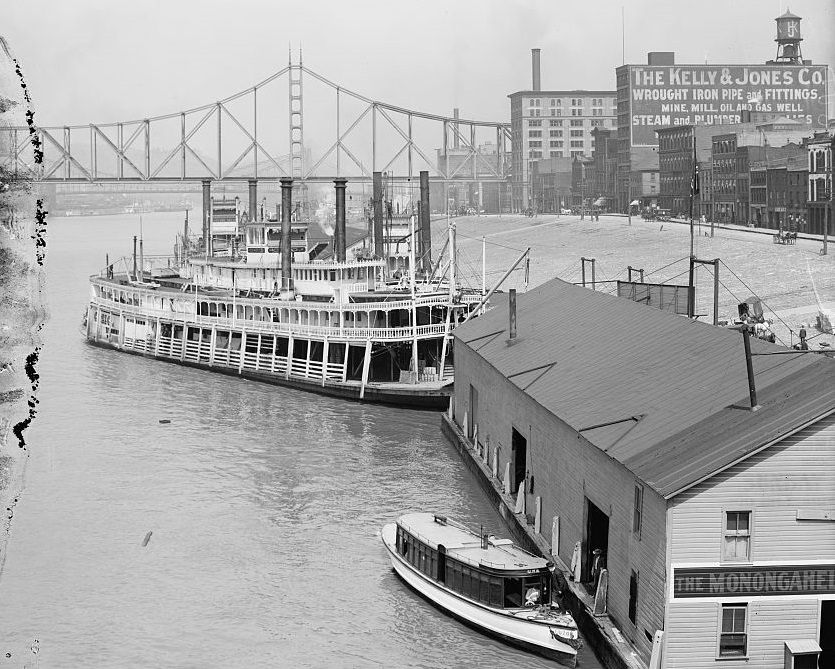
[448,215,835,348]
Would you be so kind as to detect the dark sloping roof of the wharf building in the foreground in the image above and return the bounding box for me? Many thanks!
[455,279,835,496]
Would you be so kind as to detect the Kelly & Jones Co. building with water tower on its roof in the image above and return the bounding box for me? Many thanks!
[614,12,829,211]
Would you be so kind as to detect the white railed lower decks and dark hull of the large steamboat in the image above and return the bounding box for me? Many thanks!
[85,278,466,409]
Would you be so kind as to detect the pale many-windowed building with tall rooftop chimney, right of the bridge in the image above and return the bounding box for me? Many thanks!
[508,49,615,212]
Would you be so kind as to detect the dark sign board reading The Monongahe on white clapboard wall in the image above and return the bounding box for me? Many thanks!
[673,564,835,598]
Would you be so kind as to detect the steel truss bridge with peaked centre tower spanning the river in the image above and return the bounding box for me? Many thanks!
[0,53,510,193]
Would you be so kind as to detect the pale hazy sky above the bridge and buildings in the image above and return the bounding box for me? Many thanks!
[0,0,835,125]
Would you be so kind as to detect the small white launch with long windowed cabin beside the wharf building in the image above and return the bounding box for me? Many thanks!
[382,513,582,667]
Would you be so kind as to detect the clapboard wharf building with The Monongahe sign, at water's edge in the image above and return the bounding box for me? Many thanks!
[444,279,835,669]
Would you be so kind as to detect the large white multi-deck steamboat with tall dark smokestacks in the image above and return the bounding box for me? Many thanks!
[85,173,521,408]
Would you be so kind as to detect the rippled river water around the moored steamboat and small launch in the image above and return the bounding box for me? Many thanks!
[0,213,600,668]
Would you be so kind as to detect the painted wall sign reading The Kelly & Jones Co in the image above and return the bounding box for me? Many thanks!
[629,65,827,146]
